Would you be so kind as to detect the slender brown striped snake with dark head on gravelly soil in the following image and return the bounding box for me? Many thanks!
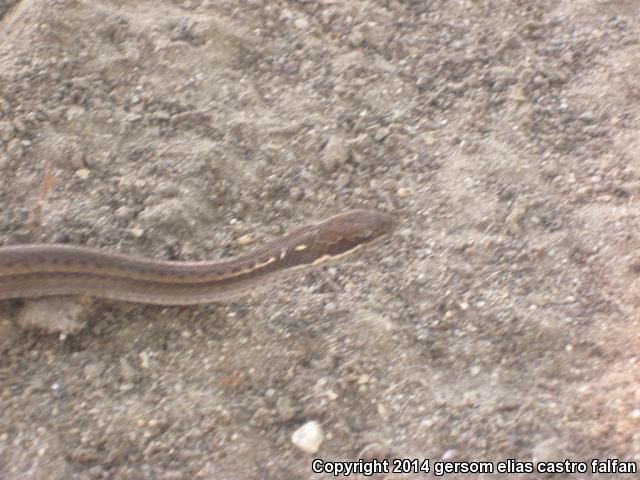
[0,209,395,305]
